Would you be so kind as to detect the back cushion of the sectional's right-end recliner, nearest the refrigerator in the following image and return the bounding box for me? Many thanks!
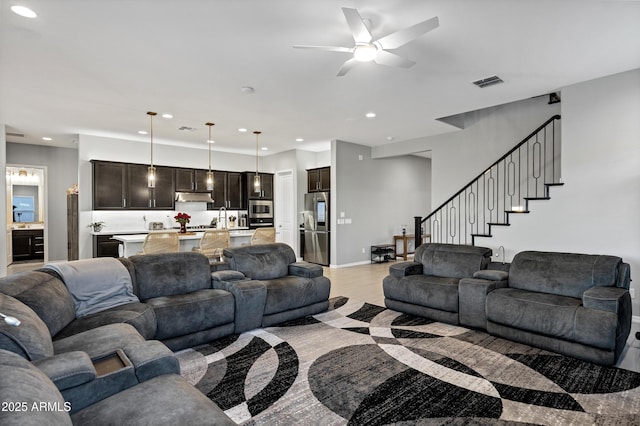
[224,243,296,280]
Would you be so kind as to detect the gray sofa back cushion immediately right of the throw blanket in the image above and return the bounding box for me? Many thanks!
[123,252,211,301]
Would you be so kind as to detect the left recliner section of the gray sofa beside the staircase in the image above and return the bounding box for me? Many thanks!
[383,243,491,324]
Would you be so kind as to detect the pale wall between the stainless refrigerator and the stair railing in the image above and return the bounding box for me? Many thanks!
[331,141,431,266]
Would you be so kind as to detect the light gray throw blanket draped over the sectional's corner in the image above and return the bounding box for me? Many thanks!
[45,257,140,318]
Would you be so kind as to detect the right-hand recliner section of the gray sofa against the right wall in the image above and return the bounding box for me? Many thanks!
[484,251,631,365]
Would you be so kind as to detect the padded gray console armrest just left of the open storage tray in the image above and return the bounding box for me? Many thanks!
[33,351,97,391]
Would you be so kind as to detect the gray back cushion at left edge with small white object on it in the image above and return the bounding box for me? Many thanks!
[0,293,53,361]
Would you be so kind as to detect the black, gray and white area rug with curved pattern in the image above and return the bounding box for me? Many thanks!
[177,298,640,425]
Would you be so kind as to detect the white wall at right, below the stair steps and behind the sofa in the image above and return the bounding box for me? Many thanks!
[478,70,640,316]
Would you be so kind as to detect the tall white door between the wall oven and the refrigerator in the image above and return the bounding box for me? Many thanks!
[274,170,300,257]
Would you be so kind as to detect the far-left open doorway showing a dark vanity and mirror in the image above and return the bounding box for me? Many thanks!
[6,164,48,265]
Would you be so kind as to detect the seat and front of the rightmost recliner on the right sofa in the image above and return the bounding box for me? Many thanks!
[486,288,618,350]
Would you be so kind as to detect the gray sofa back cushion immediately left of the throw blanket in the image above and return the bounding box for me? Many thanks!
[0,270,76,336]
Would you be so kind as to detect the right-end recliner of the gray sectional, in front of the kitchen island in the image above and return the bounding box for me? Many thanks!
[211,243,331,333]
